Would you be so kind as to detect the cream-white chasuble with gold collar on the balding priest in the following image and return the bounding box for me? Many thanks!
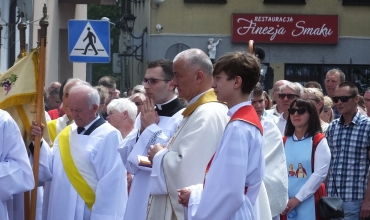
[147,89,229,220]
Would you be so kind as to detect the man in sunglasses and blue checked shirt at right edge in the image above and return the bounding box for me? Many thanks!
[326,82,370,219]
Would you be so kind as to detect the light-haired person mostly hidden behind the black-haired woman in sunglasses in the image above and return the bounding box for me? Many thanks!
[302,88,329,133]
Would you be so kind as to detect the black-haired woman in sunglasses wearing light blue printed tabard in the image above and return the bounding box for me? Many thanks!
[282,99,330,220]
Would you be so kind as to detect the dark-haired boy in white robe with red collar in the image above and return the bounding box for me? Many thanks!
[178,52,265,220]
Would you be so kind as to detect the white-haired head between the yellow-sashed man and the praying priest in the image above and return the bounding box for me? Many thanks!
[107,98,137,138]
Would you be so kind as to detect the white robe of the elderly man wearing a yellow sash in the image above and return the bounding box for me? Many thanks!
[39,117,127,220]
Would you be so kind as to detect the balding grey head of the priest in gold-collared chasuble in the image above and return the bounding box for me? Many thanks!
[172,49,213,101]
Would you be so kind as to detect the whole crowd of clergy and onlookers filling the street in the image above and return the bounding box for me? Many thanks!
[0,49,370,220]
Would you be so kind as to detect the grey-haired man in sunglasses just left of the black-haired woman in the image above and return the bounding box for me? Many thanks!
[266,81,302,136]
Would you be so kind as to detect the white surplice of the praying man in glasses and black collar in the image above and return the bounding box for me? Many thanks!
[118,98,184,220]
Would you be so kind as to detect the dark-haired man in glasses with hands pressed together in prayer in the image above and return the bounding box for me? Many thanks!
[119,59,185,220]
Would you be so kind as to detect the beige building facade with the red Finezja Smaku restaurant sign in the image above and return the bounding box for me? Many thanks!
[124,0,370,90]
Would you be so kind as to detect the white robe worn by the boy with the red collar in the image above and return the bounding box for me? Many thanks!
[188,102,265,220]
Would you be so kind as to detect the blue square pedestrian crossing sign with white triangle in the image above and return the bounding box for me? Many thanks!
[68,20,110,63]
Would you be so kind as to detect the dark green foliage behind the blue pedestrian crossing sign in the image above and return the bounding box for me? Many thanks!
[87,5,120,89]
